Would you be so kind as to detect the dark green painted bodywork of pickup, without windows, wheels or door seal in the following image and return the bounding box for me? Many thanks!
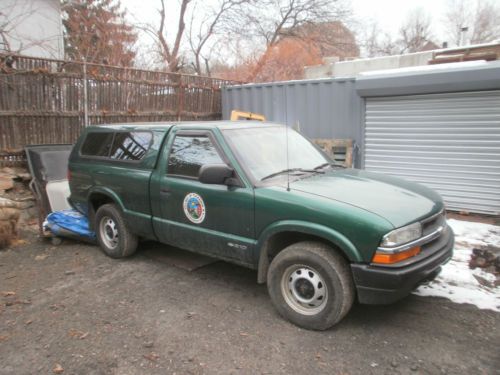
[69,122,443,268]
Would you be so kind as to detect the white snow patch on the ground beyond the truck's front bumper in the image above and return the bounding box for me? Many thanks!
[414,219,500,312]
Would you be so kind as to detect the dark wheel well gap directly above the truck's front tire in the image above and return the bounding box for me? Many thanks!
[257,232,350,284]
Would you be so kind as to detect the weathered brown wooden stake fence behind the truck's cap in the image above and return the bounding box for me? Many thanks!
[0,54,238,160]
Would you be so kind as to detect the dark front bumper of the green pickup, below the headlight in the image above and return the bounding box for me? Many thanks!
[351,227,454,304]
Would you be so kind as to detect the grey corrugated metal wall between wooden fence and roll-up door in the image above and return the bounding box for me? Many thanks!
[222,79,364,166]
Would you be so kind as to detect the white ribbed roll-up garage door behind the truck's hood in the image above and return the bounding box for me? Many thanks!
[364,90,500,215]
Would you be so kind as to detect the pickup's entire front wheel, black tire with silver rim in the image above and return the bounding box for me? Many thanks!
[267,241,355,331]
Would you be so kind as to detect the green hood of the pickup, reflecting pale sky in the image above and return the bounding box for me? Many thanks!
[290,169,444,228]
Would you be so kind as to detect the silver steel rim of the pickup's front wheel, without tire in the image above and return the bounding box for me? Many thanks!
[281,265,328,315]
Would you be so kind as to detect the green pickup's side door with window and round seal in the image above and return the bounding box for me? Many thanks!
[154,128,255,265]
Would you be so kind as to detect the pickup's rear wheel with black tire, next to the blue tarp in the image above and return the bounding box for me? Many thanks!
[95,204,138,258]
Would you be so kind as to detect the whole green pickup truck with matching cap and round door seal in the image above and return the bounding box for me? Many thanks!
[68,121,454,330]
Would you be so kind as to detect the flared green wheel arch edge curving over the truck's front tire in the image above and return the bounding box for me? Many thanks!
[257,220,362,283]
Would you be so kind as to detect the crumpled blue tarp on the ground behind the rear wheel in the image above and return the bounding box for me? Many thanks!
[44,210,96,241]
